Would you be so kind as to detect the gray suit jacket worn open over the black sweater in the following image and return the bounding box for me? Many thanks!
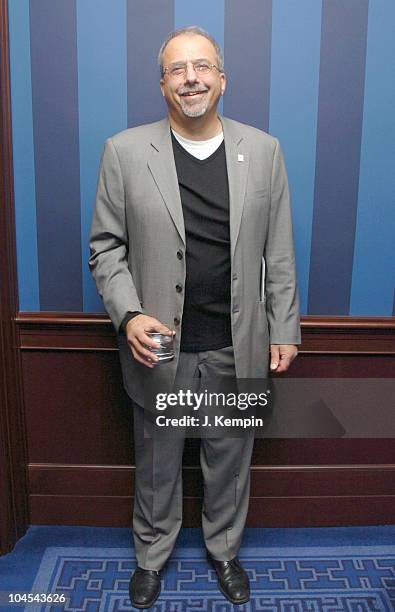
[89,117,300,404]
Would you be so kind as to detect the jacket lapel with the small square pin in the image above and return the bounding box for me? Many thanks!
[220,117,249,258]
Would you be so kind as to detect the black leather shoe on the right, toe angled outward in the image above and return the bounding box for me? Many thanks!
[207,554,250,604]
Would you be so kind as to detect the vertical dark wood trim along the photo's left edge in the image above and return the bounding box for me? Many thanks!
[0,0,28,554]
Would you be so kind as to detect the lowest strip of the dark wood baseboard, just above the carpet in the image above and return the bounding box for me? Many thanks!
[30,495,395,527]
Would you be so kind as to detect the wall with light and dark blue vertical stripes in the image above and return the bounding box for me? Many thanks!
[9,0,395,316]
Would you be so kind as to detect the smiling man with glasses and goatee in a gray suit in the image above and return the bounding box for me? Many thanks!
[89,27,300,608]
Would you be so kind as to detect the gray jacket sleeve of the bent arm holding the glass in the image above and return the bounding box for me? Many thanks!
[88,138,141,332]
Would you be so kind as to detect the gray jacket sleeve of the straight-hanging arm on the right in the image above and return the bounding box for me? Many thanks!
[264,139,301,344]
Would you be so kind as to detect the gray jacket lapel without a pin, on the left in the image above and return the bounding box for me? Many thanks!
[148,118,185,244]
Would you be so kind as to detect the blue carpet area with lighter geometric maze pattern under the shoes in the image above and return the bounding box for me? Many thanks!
[25,544,395,612]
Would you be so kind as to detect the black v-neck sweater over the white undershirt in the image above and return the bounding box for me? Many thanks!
[172,134,232,352]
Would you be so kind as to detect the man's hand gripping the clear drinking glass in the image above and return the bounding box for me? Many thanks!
[126,314,176,368]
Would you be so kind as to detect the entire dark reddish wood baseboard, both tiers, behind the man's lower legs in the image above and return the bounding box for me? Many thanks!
[30,465,395,527]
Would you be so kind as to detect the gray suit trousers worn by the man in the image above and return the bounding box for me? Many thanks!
[133,347,254,570]
